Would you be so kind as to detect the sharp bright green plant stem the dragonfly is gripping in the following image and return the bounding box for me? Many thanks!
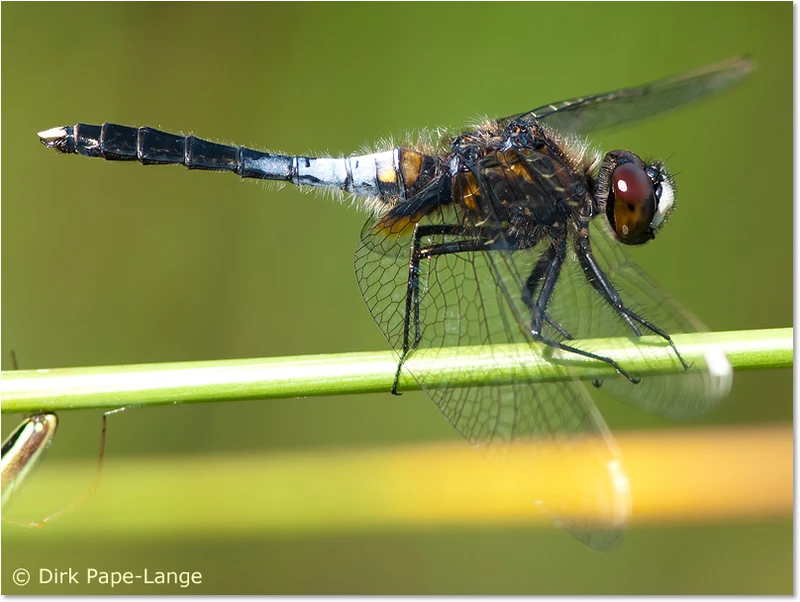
[0,328,793,413]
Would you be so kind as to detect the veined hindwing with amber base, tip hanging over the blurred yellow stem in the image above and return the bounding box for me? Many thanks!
[355,180,629,549]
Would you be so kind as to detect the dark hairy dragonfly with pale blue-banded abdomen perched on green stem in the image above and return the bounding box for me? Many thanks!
[39,57,755,549]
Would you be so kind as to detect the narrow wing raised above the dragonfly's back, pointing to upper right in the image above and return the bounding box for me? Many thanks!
[500,56,756,133]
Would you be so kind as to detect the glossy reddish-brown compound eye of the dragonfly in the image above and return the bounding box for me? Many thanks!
[611,162,656,245]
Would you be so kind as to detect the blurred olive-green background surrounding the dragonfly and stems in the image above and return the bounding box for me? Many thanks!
[0,3,792,594]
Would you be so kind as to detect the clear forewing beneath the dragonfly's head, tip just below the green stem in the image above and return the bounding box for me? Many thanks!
[493,217,733,420]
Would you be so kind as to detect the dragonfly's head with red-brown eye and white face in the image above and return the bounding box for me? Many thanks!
[597,150,675,245]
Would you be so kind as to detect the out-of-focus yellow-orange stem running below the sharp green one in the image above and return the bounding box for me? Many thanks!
[3,425,792,539]
